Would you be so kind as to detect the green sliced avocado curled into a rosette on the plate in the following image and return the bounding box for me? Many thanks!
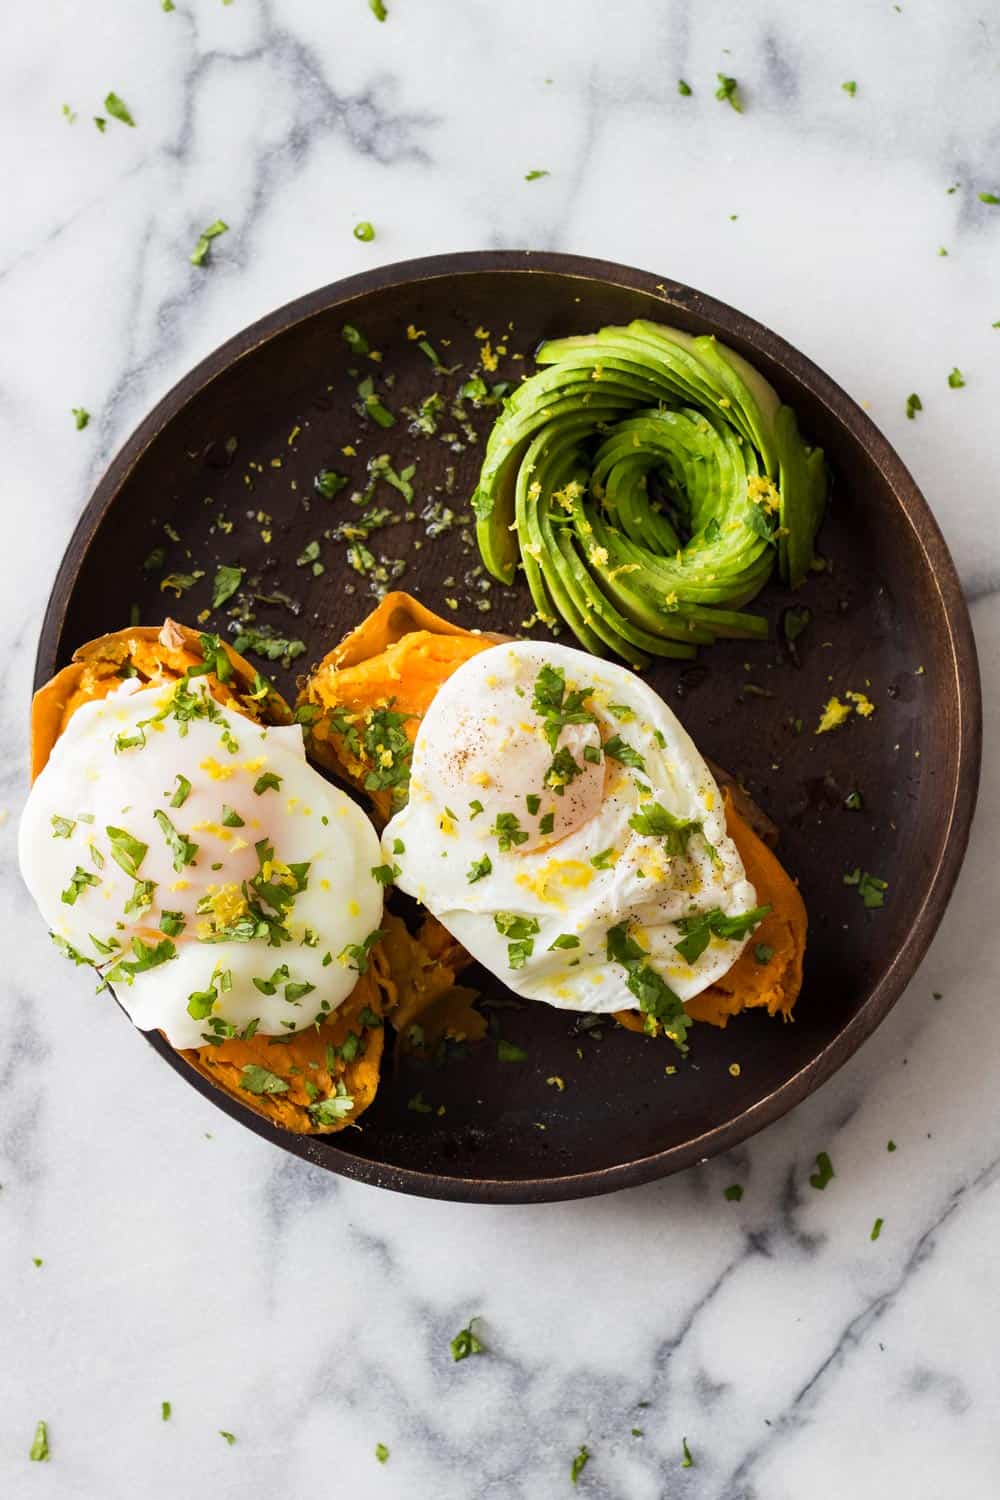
[472,320,826,666]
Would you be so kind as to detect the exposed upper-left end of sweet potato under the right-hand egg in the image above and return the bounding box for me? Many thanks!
[300,591,501,824]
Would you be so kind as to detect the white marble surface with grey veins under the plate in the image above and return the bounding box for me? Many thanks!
[0,0,1000,1500]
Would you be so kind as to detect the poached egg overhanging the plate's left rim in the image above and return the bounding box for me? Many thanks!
[18,680,384,1047]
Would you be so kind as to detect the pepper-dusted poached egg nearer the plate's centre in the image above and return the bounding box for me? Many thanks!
[382,642,756,1013]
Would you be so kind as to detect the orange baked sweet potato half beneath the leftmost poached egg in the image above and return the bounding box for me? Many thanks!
[31,620,395,1134]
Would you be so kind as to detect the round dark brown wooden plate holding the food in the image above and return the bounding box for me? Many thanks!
[36,252,981,1202]
